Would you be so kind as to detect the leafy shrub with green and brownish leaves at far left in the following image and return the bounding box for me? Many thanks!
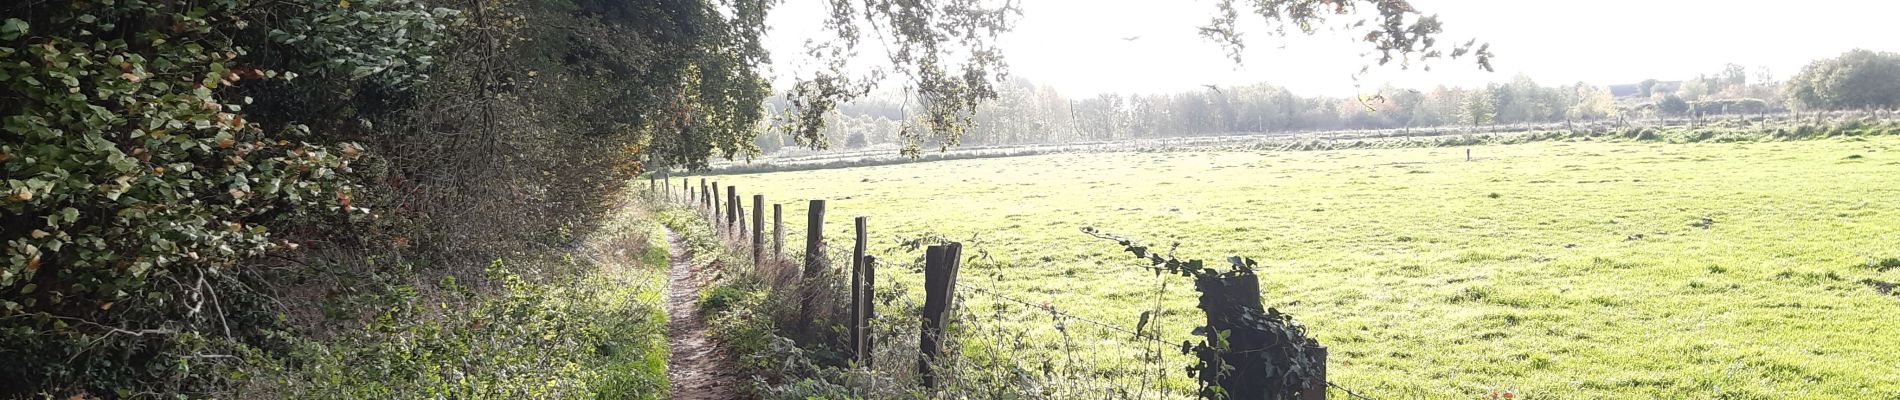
[0,0,443,391]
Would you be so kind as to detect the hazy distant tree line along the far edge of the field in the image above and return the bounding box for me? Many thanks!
[756,49,1900,152]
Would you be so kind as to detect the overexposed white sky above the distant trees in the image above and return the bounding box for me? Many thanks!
[766,0,1900,97]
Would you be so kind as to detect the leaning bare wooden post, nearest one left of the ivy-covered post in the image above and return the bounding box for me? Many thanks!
[918,243,963,389]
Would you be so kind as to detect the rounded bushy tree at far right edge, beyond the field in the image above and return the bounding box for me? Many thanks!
[1784,49,1900,110]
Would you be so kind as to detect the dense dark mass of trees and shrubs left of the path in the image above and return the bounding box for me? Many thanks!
[0,0,770,396]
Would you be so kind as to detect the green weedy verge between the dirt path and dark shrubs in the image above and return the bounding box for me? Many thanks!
[234,193,667,398]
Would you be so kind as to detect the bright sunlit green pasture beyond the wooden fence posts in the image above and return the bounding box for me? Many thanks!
[713,136,1900,398]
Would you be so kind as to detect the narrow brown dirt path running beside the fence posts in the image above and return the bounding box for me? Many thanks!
[665,231,743,400]
